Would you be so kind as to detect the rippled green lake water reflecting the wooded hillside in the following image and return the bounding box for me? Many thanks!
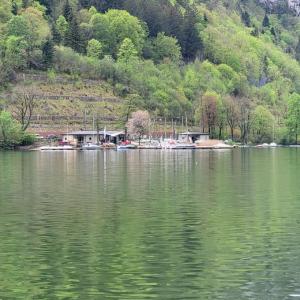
[0,148,300,300]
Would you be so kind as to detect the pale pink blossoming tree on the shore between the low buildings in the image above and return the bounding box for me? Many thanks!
[127,110,151,144]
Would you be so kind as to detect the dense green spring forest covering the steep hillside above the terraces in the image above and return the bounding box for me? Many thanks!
[0,0,300,143]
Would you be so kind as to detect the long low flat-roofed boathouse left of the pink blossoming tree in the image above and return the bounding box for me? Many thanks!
[62,130,125,146]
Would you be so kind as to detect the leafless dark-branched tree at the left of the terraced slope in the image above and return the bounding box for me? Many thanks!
[12,87,37,131]
